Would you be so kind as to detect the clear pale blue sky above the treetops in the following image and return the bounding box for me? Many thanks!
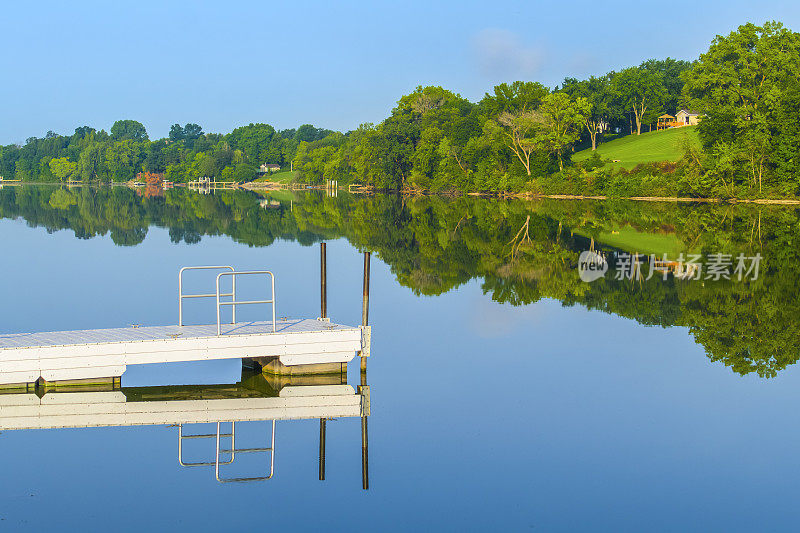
[0,0,800,144]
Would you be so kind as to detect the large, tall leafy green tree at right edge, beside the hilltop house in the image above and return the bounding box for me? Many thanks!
[684,22,800,191]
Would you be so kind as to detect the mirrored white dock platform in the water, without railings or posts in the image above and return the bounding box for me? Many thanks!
[0,375,369,431]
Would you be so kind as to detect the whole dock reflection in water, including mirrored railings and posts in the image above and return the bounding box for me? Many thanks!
[0,369,370,488]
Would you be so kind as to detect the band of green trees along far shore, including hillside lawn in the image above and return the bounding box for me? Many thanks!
[0,22,800,199]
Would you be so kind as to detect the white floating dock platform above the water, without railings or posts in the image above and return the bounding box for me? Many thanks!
[0,319,370,385]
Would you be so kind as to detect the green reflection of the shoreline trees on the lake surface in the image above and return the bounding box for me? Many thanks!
[0,187,800,377]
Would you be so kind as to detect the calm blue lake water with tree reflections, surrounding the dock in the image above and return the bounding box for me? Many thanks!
[0,186,800,531]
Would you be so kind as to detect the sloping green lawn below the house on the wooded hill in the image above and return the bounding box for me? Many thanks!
[572,126,700,168]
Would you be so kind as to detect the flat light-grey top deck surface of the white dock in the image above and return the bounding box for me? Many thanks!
[0,319,358,353]
